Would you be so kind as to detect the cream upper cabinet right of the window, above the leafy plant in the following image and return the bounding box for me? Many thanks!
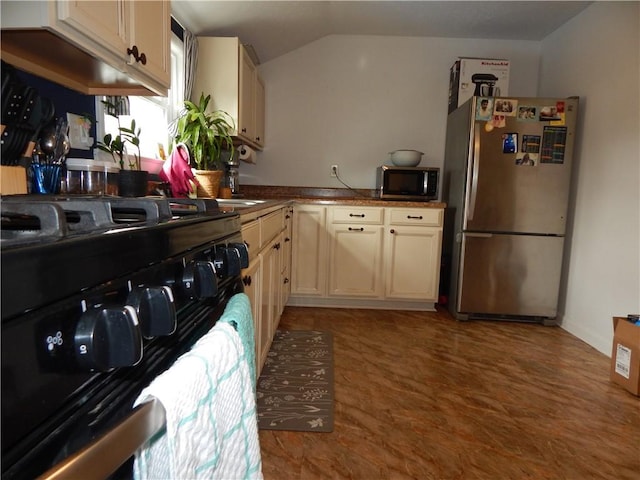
[192,37,264,149]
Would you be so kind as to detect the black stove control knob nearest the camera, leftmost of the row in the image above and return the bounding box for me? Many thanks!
[74,305,142,372]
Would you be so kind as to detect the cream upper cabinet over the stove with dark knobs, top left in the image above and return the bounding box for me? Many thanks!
[1,0,171,96]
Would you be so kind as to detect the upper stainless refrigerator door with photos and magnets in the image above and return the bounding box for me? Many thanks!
[463,99,577,235]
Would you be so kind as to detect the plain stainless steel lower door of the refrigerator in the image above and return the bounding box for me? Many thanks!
[456,233,564,318]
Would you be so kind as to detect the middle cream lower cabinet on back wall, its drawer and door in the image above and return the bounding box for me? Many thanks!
[328,207,384,297]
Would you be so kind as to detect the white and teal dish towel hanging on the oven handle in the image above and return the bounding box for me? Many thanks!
[134,294,263,480]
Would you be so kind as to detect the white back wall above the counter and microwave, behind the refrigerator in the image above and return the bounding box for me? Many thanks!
[240,35,540,188]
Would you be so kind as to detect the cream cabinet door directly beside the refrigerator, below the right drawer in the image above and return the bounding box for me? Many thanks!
[385,225,442,302]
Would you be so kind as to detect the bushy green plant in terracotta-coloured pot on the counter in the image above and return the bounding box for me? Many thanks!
[175,93,235,198]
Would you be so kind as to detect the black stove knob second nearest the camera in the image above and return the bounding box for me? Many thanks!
[127,286,177,338]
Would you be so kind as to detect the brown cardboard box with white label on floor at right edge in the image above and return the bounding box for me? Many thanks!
[611,317,640,395]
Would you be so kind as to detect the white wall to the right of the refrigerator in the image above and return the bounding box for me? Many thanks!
[540,2,640,355]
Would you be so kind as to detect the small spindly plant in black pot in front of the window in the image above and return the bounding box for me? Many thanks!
[96,100,149,197]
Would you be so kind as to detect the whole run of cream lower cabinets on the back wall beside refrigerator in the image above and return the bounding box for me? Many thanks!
[289,204,444,310]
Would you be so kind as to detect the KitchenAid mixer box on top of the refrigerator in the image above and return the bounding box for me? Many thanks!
[449,57,509,113]
